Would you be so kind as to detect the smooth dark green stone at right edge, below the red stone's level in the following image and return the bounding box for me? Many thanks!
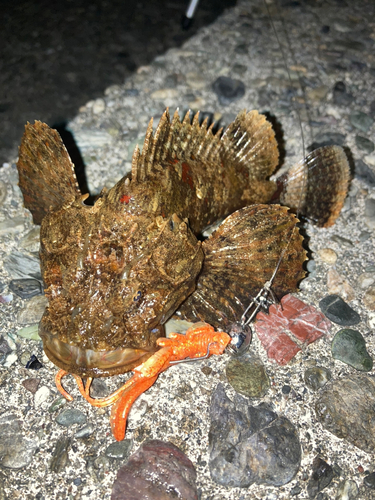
[331,328,373,372]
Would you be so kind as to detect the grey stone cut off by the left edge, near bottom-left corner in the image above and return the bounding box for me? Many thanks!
[0,414,38,469]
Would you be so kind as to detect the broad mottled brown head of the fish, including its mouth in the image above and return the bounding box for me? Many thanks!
[40,197,203,377]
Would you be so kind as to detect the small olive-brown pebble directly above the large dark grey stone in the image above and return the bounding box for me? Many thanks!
[226,352,270,398]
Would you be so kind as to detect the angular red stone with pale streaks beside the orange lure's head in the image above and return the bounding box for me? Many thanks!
[255,295,331,365]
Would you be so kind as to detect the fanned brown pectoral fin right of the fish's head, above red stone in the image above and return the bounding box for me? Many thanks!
[177,205,306,331]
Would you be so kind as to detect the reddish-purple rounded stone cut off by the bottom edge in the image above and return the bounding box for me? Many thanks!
[111,440,198,500]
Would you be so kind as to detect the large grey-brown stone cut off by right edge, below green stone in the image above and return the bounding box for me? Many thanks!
[315,376,375,453]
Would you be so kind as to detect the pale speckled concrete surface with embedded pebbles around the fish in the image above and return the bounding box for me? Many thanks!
[0,0,375,500]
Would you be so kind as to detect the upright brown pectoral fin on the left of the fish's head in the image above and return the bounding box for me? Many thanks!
[17,121,81,224]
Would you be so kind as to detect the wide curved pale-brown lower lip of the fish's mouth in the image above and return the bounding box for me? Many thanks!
[39,321,163,378]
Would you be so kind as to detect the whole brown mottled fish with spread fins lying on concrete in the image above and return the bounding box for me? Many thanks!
[18,111,349,377]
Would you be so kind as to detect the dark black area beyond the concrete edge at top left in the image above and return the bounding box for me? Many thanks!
[0,0,236,167]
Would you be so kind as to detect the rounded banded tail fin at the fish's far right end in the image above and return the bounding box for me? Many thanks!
[280,146,350,227]
